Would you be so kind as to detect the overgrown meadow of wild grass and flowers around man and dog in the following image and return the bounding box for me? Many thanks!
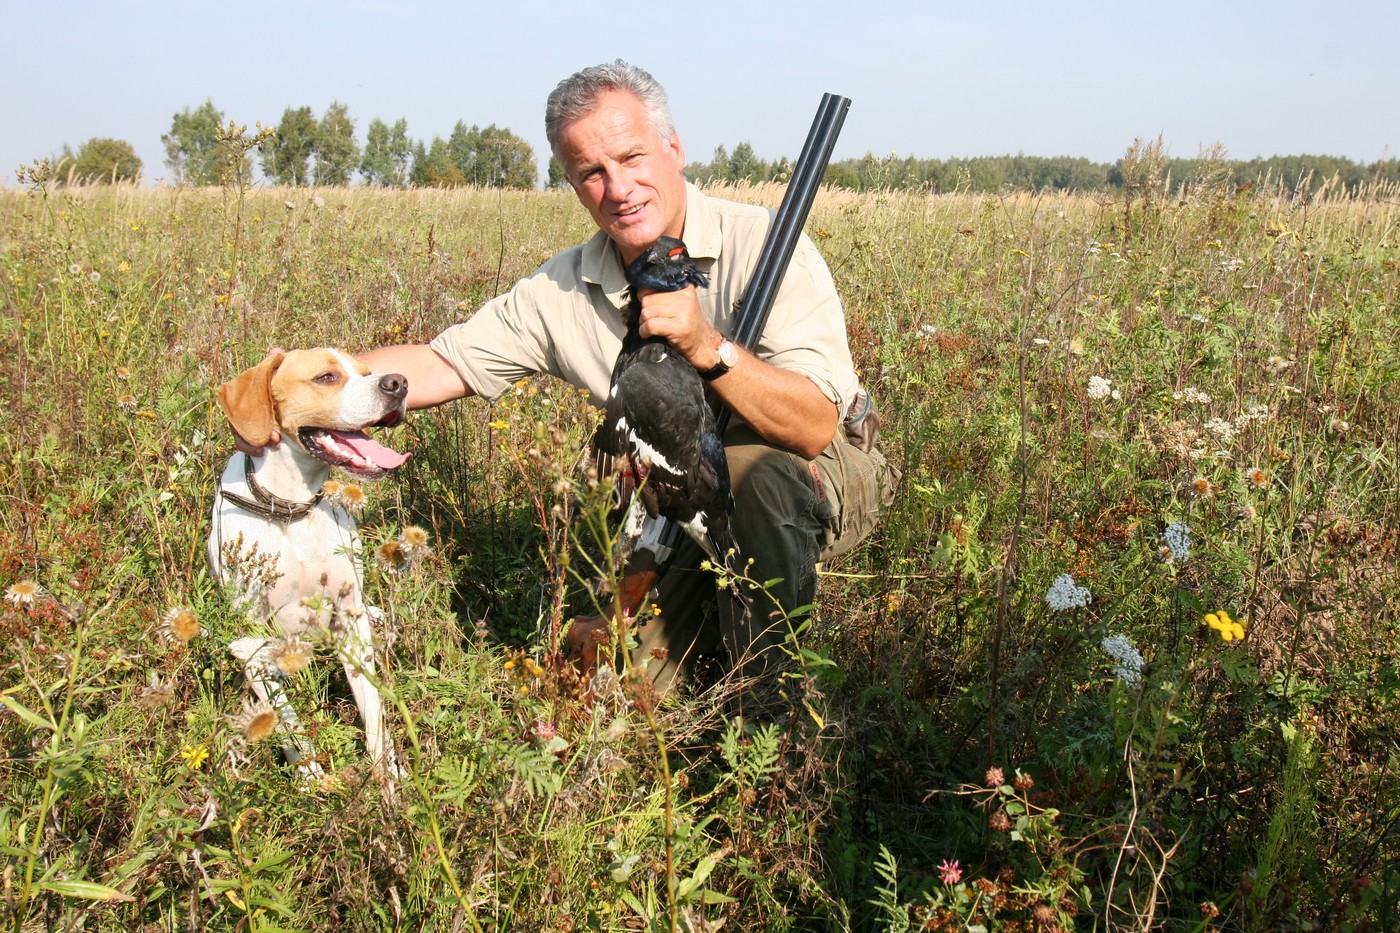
[0,161,1400,932]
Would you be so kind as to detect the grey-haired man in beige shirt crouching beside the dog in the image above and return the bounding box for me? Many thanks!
[372,60,889,711]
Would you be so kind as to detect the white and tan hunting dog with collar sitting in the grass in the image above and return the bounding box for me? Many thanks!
[209,349,409,780]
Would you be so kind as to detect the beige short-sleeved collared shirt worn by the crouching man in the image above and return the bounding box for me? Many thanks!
[431,184,857,412]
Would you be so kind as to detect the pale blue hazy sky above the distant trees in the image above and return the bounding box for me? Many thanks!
[0,0,1400,186]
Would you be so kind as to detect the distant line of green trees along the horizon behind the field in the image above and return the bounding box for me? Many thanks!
[43,101,1400,192]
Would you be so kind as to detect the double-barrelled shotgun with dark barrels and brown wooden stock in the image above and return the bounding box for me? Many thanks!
[567,94,851,678]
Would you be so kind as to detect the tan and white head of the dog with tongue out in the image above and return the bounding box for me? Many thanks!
[218,347,409,479]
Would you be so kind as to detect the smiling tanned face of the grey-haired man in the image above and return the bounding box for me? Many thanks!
[559,91,686,262]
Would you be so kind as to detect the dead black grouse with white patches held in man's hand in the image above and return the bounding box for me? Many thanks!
[594,237,738,569]
